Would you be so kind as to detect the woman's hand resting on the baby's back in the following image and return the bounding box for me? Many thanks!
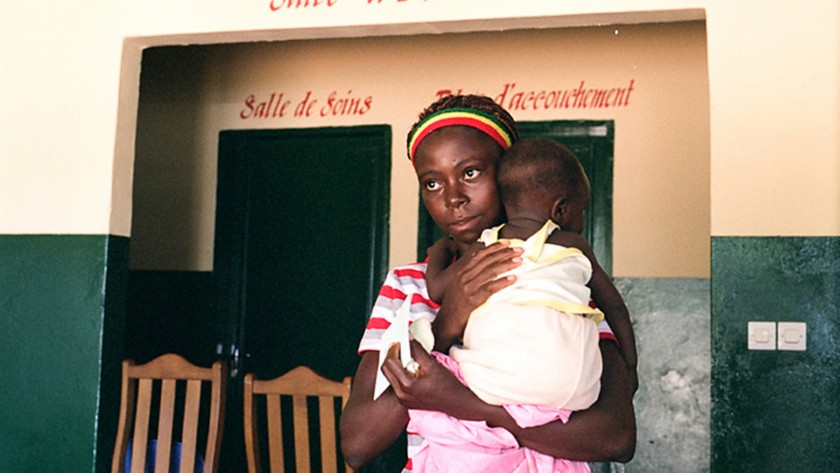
[432,242,523,353]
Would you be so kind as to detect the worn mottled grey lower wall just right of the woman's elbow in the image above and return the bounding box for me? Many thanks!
[612,278,708,473]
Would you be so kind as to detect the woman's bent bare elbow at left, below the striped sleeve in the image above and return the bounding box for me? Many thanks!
[340,351,408,469]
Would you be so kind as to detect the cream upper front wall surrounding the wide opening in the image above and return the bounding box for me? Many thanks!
[0,0,840,235]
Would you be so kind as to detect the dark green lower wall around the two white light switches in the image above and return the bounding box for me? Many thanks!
[712,237,840,473]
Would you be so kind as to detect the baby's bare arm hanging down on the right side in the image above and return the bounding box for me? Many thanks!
[549,231,639,392]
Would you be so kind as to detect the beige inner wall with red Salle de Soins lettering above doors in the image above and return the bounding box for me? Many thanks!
[131,22,710,277]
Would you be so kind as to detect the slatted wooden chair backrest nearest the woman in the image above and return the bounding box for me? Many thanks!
[244,366,353,473]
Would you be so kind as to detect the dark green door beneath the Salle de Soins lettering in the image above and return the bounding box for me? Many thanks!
[214,126,391,471]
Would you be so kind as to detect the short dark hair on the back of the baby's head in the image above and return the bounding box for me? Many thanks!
[497,138,589,209]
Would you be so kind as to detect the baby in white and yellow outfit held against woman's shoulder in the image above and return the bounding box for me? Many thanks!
[426,138,636,410]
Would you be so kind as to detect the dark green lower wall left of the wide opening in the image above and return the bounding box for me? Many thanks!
[0,235,128,473]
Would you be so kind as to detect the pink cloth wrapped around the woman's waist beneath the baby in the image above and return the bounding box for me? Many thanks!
[407,352,589,473]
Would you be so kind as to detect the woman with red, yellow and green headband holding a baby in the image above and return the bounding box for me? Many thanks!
[341,96,636,471]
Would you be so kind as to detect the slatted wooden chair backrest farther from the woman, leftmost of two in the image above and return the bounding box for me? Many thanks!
[111,353,227,473]
